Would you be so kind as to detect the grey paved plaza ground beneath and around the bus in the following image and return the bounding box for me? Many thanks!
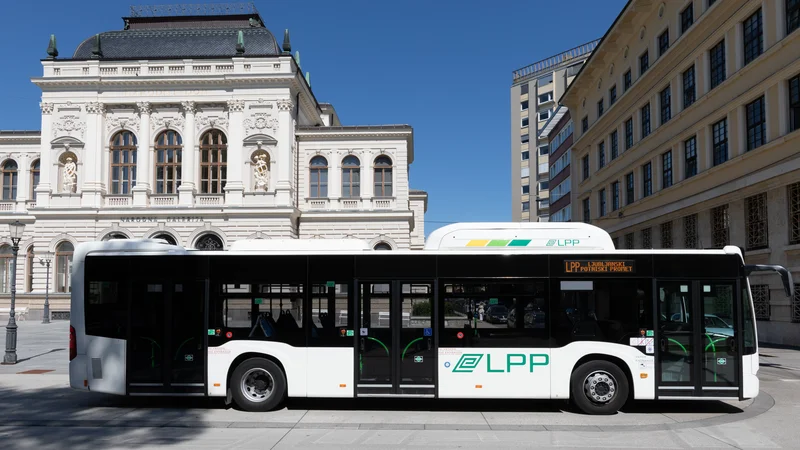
[0,322,800,449]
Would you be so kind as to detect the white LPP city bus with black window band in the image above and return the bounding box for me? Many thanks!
[69,223,793,414]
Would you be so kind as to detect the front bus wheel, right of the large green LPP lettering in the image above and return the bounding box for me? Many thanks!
[570,360,629,414]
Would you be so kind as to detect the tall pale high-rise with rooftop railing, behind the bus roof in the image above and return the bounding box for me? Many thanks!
[511,40,599,222]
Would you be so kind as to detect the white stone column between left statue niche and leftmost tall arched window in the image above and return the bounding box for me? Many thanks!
[81,102,105,208]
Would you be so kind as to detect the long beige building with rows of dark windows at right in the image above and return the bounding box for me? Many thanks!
[561,0,800,345]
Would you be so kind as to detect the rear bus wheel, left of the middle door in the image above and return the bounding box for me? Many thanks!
[230,358,286,412]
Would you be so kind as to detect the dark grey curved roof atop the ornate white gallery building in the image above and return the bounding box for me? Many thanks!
[72,27,281,60]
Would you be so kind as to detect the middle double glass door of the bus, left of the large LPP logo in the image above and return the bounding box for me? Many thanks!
[356,280,436,397]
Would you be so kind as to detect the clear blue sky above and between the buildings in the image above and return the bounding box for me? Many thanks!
[0,0,626,234]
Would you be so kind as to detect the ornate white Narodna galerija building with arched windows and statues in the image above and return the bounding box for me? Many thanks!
[0,4,427,318]
